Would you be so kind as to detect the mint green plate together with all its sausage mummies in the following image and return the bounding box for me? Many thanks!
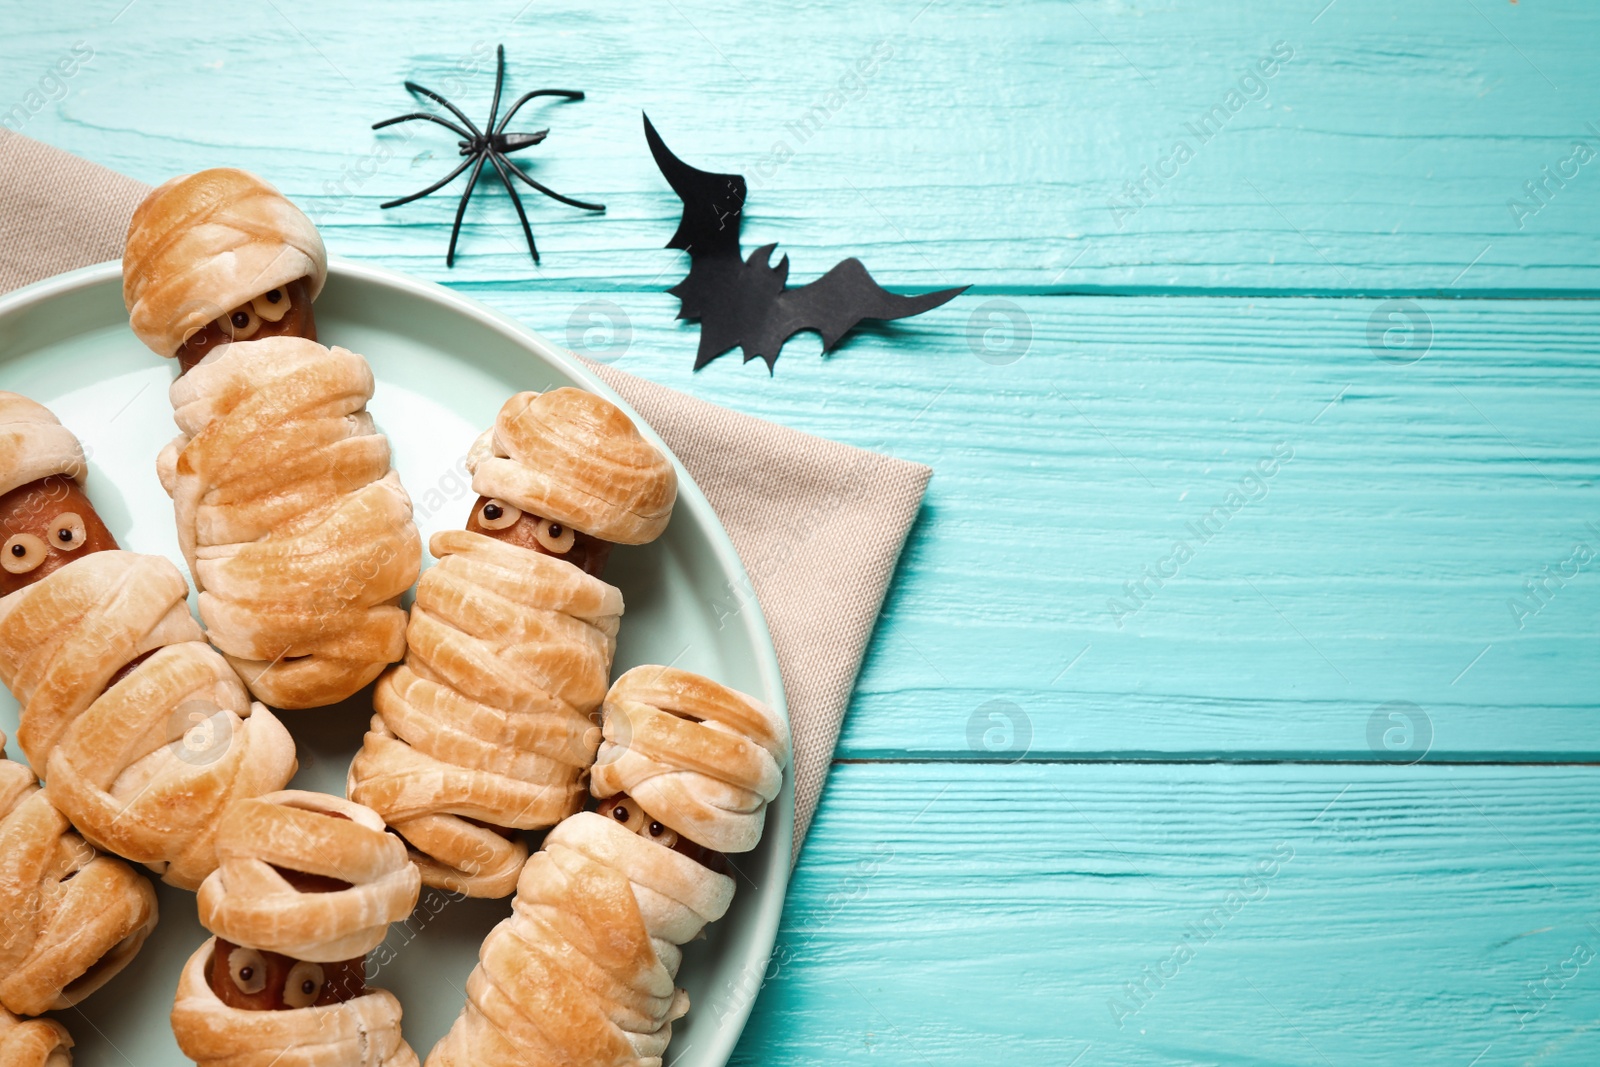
[0,170,794,1067]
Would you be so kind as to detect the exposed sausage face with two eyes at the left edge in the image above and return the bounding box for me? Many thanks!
[0,474,117,597]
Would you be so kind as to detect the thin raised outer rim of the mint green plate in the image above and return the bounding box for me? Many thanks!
[0,254,795,1064]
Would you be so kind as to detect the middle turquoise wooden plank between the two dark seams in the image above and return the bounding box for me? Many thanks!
[374,290,1600,760]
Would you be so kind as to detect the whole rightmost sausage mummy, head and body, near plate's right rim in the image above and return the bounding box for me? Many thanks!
[427,667,789,1067]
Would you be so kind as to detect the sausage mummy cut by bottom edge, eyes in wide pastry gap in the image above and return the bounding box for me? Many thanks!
[173,790,421,1067]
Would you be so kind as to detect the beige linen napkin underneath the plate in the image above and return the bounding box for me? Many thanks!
[0,130,933,856]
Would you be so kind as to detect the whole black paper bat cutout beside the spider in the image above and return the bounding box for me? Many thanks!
[645,115,968,373]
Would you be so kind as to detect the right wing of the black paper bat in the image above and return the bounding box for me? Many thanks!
[741,258,968,371]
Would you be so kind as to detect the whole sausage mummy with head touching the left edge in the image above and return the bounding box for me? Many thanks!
[0,394,296,889]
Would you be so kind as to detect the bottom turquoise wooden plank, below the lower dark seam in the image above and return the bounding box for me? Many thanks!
[734,765,1600,1067]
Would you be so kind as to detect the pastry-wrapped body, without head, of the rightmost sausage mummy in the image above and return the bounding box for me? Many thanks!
[427,811,733,1067]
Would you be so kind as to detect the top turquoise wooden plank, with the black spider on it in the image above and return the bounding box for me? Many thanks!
[0,0,1600,293]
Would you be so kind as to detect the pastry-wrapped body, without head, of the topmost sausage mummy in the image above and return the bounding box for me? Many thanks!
[158,338,422,709]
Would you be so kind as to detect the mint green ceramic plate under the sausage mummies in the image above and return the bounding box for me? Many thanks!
[0,261,794,1067]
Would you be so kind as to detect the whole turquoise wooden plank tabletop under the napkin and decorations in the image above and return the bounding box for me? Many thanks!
[0,0,1600,1067]
